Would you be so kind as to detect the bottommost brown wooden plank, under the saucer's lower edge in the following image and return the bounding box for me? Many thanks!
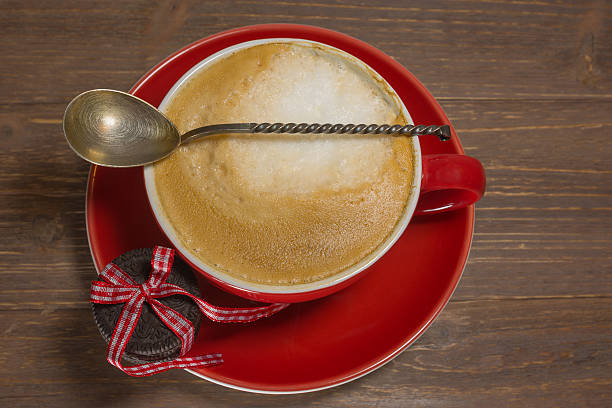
[0,298,612,407]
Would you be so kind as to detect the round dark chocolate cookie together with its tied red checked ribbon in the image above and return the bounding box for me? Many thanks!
[90,246,288,376]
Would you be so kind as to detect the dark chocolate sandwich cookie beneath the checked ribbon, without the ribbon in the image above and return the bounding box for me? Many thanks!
[91,248,202,363]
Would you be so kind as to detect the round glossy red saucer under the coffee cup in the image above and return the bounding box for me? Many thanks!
[86,24,474,393]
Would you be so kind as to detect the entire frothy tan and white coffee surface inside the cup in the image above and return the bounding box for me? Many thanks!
[153,43,414,285]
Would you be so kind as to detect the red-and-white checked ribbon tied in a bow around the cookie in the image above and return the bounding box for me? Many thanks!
[90,246,288,377]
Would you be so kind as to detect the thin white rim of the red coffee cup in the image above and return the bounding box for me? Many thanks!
[143,37,422,296]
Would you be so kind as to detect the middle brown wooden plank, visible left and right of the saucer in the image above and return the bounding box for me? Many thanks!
[0,96,612,309]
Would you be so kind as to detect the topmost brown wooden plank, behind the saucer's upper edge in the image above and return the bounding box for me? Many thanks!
[0,0,612,103]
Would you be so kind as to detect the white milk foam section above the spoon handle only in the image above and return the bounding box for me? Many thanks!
[233,47,399,123]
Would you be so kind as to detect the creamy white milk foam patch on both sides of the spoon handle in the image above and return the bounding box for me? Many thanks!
[186,47,399,193]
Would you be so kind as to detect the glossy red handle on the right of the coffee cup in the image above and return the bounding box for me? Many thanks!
[414,154,486,215]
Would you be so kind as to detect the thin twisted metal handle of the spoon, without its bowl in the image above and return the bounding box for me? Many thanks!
[181,123,451,144]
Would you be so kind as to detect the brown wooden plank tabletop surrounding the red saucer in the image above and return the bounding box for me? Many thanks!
[0,0,612,407]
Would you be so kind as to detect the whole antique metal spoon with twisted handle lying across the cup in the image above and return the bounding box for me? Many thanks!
[64,89,451,167]
